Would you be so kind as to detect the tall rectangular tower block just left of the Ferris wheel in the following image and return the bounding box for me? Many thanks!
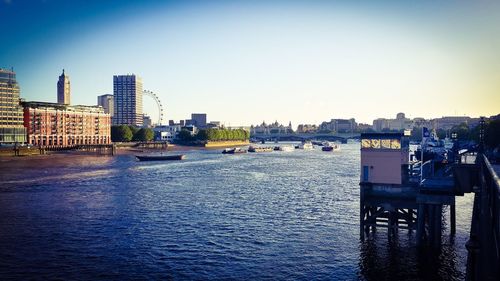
[113,75,143,127]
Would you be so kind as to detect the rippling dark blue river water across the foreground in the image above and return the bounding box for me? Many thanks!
[0,143,473,280]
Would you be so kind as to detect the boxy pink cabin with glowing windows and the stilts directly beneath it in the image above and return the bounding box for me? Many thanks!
[360,133,418,237]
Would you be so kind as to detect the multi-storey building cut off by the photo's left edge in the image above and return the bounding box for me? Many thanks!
[0,68,26,144]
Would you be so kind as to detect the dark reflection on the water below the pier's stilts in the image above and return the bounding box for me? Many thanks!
[359,221,465,280]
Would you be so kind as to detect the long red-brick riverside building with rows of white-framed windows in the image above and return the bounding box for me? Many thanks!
[21,102,111,146]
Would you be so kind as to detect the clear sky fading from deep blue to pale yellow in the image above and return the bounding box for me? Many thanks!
[0,0,500,126]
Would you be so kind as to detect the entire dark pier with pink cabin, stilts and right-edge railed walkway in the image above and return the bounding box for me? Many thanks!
[360,127,500,280]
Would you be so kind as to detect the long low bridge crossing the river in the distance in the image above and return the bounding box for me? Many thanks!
[250,133,361,141]
